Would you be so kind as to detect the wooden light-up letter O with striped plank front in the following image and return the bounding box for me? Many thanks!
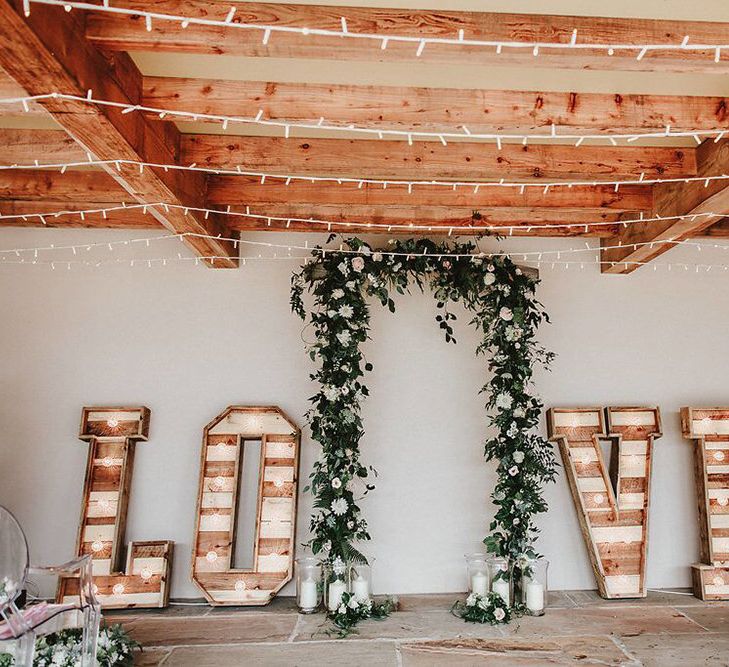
[192,406,300,605]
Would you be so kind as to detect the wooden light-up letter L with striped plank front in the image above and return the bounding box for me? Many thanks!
[58,407,173,609]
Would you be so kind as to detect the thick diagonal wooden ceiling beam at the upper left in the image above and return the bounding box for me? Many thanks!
[0,0,237,267]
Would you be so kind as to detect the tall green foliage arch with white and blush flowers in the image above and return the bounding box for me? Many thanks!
[291,235,556,628]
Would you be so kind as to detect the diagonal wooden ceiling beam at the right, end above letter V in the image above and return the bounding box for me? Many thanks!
[601,139,729,274]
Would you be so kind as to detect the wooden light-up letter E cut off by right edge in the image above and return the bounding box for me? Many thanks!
[681,407,729,600]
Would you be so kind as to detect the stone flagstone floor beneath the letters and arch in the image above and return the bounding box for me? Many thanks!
[106,591,729,667]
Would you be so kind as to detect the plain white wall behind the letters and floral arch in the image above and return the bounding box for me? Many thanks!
[0,230,729,598]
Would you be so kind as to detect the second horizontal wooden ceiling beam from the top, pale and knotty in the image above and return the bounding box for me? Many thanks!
[143,77,729,135]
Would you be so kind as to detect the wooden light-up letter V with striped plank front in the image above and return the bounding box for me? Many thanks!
[547,408,661,598]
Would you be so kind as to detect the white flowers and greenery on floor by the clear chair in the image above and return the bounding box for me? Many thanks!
[0,625,139,667]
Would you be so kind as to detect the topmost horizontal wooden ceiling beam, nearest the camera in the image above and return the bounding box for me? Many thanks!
[86,0,729,74]
